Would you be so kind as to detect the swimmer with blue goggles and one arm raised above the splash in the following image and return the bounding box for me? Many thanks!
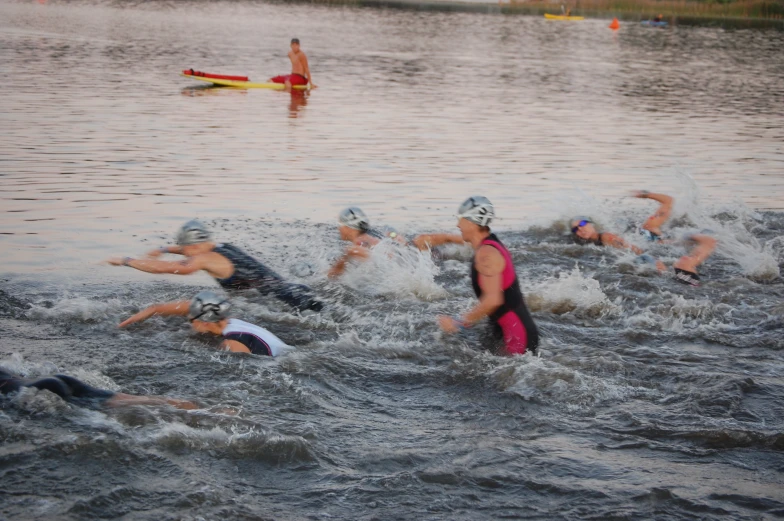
[570,190,673,255]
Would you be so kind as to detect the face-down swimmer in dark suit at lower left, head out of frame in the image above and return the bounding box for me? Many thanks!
[0,367,199,410]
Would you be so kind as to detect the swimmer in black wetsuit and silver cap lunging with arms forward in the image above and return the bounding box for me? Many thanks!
[107,220,323,311]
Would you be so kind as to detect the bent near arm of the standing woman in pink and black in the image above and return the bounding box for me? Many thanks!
[438,246,506,333]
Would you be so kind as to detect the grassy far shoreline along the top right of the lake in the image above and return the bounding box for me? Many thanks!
[294,0,784,30]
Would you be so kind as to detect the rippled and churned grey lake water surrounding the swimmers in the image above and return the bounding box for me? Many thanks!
[0,1,784,520]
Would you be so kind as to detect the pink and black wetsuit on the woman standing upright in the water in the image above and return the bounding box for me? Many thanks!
[471,233,539,354]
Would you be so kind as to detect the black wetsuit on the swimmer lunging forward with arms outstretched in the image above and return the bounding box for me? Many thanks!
[212,244,324,311]
